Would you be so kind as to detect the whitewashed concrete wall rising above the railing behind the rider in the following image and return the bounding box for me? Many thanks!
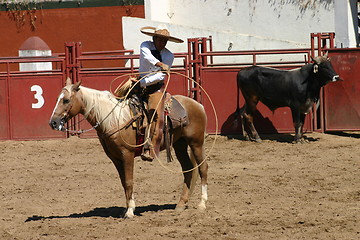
[123,0,335,55]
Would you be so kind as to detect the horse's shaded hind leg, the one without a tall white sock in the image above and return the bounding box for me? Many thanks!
[173,138,196,210]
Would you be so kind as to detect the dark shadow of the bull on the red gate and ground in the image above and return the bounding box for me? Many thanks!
[220,111,317,143]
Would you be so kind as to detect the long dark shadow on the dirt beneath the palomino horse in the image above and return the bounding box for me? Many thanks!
[25,204,176,222]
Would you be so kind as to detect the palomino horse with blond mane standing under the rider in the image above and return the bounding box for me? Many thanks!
[49,79,208,218]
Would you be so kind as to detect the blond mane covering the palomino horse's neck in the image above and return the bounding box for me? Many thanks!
[80,86,131,132]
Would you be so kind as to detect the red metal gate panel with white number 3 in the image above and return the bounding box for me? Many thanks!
[0,57,65,140]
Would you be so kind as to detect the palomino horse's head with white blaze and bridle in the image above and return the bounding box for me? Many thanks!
[49,78,82,131]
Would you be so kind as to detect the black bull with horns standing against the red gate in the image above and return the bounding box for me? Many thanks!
[235,53,341,142]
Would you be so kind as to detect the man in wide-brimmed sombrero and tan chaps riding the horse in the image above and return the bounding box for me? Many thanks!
[138,25,184,161]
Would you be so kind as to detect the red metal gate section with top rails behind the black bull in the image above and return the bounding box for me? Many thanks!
[189,33,360,134]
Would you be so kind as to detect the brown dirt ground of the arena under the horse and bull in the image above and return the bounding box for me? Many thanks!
[0,133,360,240]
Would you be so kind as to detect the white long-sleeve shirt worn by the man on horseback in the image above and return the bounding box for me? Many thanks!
[139,41,174,87]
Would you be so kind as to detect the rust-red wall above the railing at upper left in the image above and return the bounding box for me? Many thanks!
[0,0,145,60]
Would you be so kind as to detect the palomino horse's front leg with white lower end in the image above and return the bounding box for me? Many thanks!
[113,153,135,218]
